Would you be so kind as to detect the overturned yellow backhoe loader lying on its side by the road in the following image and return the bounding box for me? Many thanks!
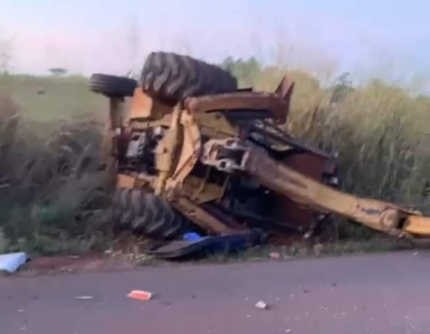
[90,52,430,245]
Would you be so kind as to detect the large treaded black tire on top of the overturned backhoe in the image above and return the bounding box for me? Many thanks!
[140,52,237,101]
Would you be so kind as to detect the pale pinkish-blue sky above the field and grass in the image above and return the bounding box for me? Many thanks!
[0,0,430,86]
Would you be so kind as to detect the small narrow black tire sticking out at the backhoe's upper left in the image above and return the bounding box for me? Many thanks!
[90,73,137,98]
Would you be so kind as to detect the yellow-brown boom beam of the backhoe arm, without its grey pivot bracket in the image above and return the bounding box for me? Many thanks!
[242,148,426,237]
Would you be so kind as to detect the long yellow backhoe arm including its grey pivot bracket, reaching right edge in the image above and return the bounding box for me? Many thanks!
[201,139,430,237]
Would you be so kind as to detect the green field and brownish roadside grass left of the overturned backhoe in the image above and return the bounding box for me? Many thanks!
[0,75,111,254]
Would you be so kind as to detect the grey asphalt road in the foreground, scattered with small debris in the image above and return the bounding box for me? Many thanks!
[0,252,430,334]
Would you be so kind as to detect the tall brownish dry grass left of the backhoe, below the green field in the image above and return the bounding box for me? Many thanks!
[0,79,115,254]
